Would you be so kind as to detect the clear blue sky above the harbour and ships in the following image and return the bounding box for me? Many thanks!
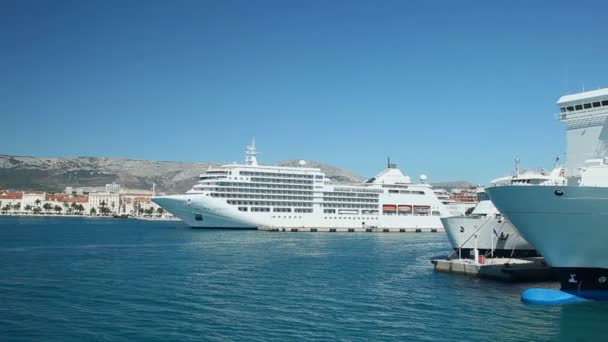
[0,0,608,183]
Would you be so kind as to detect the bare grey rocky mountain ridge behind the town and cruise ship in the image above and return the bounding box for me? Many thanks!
[0,155,363,194]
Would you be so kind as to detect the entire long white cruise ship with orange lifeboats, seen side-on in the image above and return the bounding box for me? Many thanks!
[152,143,448,230]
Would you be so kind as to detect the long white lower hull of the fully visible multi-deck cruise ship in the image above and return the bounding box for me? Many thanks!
[152,194,443,230]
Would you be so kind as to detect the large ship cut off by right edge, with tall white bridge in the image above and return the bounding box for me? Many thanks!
[486,89,608,300]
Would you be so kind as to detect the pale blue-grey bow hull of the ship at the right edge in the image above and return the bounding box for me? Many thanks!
[486,186,608,300]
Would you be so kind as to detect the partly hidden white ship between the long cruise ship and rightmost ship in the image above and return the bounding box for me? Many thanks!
[441,160,566,258]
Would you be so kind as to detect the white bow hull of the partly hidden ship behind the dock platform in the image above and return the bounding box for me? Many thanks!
[441,215,539,258]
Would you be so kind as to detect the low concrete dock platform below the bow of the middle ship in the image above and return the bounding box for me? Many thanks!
[431,258,557,282]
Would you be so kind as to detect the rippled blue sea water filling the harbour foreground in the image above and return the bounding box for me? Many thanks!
[0,217,608,341]
